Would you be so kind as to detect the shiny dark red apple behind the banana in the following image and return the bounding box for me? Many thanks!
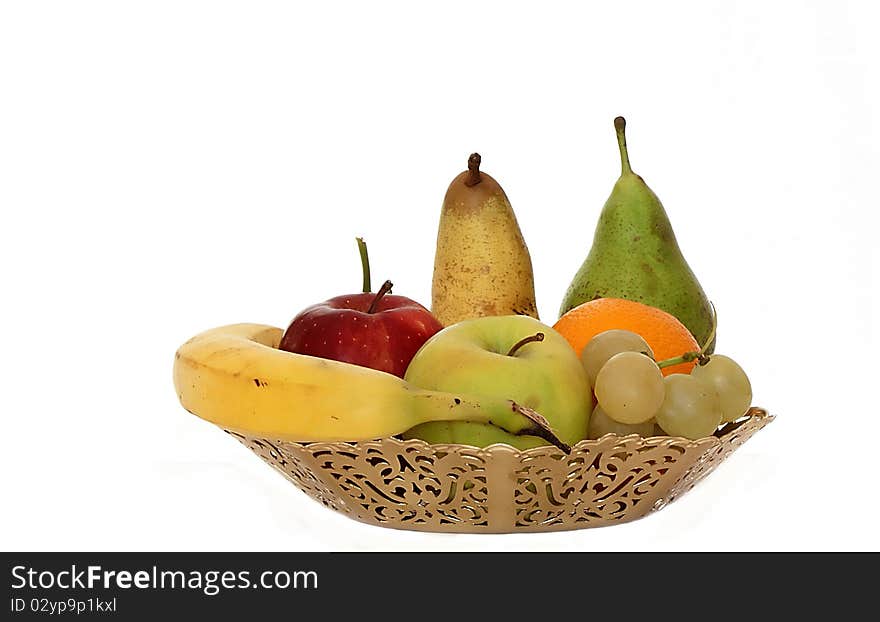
[278,240,443,378]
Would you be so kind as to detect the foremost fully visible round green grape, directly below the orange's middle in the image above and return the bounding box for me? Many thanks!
[596,352,665,424]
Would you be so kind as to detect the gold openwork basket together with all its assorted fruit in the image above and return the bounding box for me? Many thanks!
[174,117,773,533]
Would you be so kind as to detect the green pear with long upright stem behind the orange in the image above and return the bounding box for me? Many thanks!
[559,117,715,353]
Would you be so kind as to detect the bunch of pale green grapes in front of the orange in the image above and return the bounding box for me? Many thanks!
[581,330,752,439]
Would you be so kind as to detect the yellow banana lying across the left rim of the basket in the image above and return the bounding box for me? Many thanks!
[174,324,569,452]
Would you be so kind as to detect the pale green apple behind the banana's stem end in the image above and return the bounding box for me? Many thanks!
[404,315,593,449]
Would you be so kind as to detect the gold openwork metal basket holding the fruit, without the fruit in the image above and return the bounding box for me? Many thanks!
[227,408,774,533]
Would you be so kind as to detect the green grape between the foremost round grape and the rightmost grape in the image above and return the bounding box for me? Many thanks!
[656,374,721,440]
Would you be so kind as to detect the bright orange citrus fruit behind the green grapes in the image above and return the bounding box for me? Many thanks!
[553,298,700,376]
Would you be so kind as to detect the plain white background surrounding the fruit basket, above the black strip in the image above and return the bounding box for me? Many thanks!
[0,0,880,551]
